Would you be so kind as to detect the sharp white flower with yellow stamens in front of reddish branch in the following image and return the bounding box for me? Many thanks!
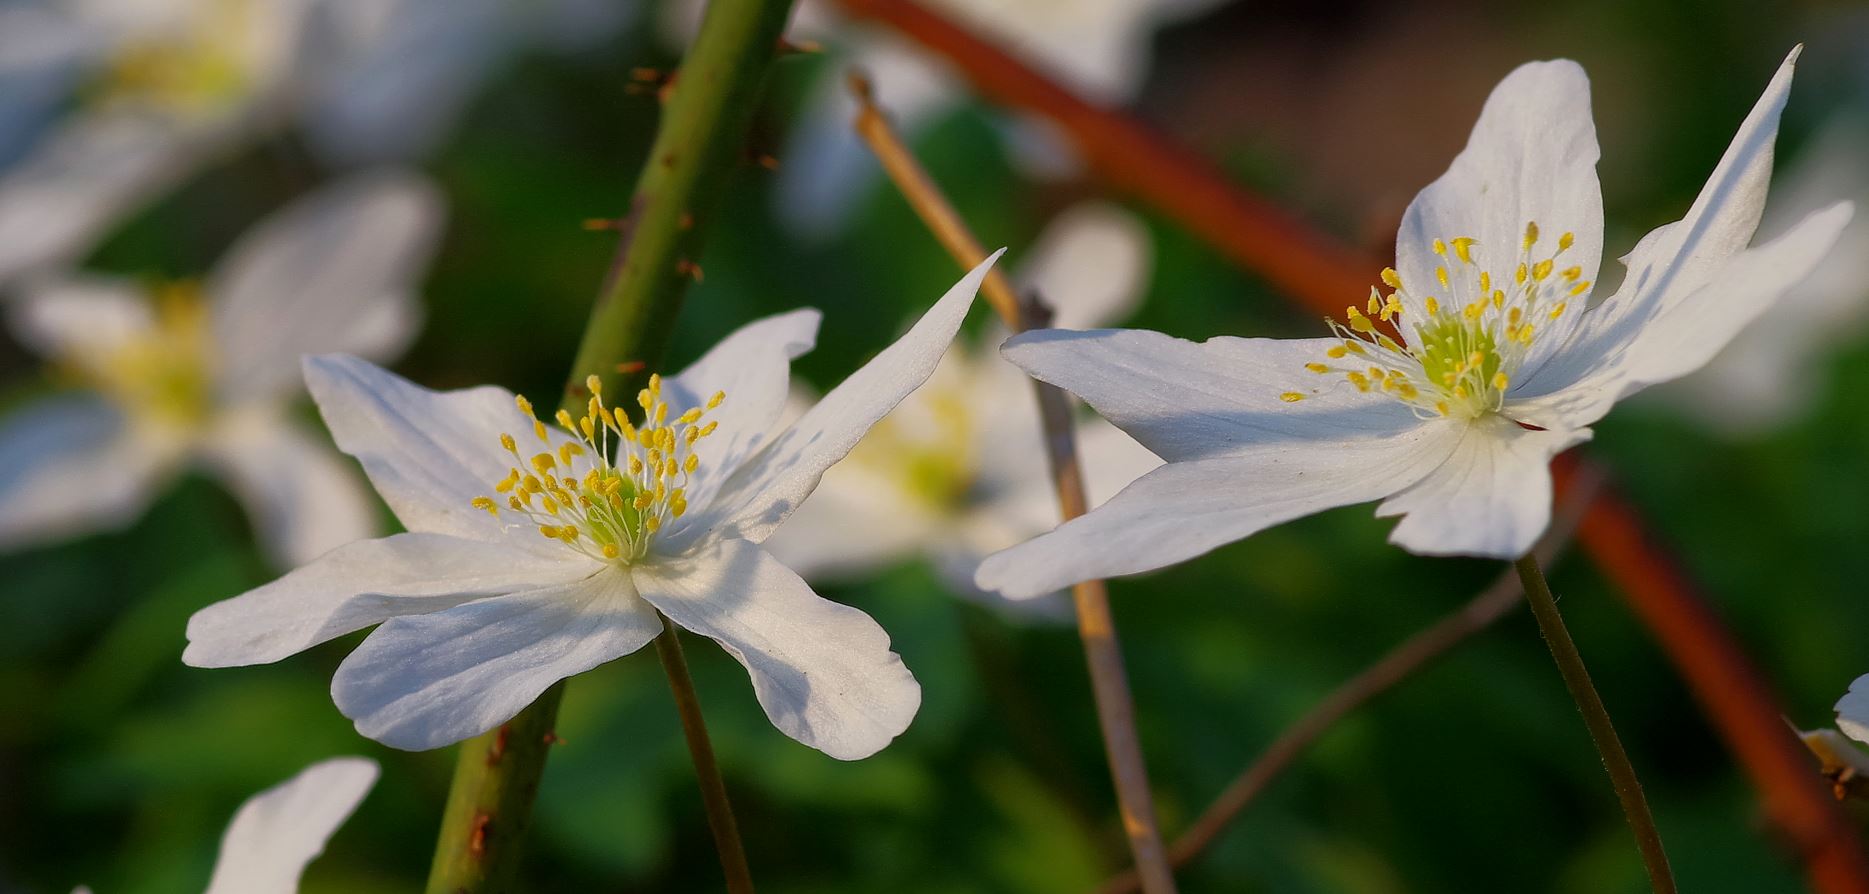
[977,52,1850,598]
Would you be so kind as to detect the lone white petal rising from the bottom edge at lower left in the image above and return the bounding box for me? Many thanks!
[207,757,378,894]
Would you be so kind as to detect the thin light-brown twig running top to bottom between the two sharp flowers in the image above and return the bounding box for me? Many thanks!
[850,75,1176,894]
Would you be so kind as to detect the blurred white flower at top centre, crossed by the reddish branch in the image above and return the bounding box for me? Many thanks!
[662,0,1224,238]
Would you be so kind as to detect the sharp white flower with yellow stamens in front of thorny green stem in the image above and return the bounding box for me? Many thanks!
[183,254,998,759]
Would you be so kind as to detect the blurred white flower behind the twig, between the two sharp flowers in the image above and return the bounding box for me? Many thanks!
[766,204,1161,619]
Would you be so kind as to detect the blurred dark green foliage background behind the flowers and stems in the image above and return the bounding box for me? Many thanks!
[0,0,1869,894]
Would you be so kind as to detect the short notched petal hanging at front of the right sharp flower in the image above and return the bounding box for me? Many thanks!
[1376,415,1591,559]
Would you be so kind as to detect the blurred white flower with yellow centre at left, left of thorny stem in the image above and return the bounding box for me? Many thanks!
[0,172,441,565]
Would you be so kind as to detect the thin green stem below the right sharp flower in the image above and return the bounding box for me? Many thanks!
[1516,554,1675,894]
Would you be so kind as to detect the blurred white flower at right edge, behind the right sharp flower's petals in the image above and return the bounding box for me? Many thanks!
[1656,112,1869,436]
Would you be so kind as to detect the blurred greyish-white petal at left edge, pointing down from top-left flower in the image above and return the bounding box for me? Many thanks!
[0,112,200,281]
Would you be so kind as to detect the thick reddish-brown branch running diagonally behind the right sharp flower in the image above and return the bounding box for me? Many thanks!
[839,0,1869,894]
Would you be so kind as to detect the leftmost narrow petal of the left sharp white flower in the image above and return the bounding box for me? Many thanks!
[181,533,592,668]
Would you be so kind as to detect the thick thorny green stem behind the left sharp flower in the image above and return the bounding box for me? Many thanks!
[428,0,792,894]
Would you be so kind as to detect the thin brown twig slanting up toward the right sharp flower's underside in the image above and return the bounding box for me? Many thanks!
[1097,467,1602,894]
